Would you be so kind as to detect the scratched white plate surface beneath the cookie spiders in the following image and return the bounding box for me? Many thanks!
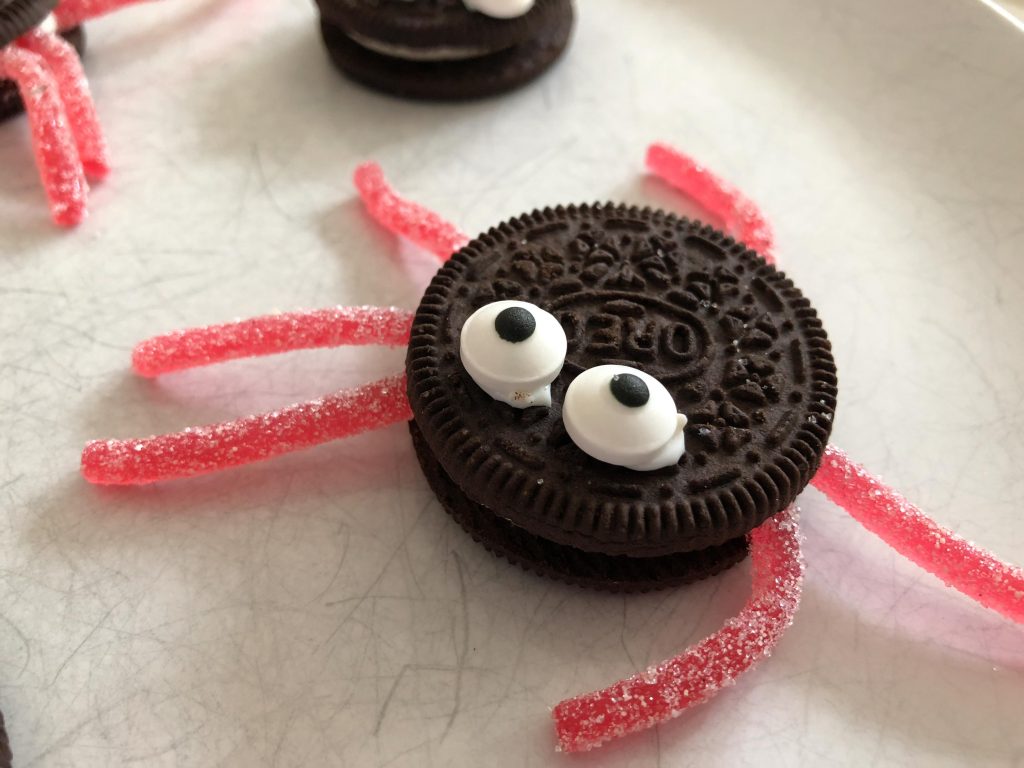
[0,0,1024,767]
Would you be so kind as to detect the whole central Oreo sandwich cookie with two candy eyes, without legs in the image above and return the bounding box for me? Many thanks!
[407,205,838,589]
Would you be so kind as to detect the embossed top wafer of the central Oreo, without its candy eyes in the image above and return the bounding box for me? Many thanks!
[407,204,838,557]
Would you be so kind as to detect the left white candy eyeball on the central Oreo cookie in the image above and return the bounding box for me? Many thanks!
[459,301,568,409]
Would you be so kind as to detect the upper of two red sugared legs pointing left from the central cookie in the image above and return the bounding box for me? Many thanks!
[132,306,413,377]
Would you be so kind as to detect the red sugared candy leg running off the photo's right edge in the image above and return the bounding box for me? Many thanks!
[811,445,1024,624]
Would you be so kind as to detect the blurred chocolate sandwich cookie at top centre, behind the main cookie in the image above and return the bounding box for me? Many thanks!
[317,0,573,100]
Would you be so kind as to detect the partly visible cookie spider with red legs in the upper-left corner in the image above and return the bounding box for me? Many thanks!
[0,0,146,226]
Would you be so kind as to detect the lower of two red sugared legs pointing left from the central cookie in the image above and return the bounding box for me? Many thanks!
[82,375,413,485]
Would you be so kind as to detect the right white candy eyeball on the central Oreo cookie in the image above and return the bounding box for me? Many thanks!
[562,366,686,472]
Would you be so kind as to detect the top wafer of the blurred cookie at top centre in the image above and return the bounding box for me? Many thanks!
[316,0,569,52]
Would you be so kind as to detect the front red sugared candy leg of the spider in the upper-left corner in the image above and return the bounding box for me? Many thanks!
[0,45,89,226]
